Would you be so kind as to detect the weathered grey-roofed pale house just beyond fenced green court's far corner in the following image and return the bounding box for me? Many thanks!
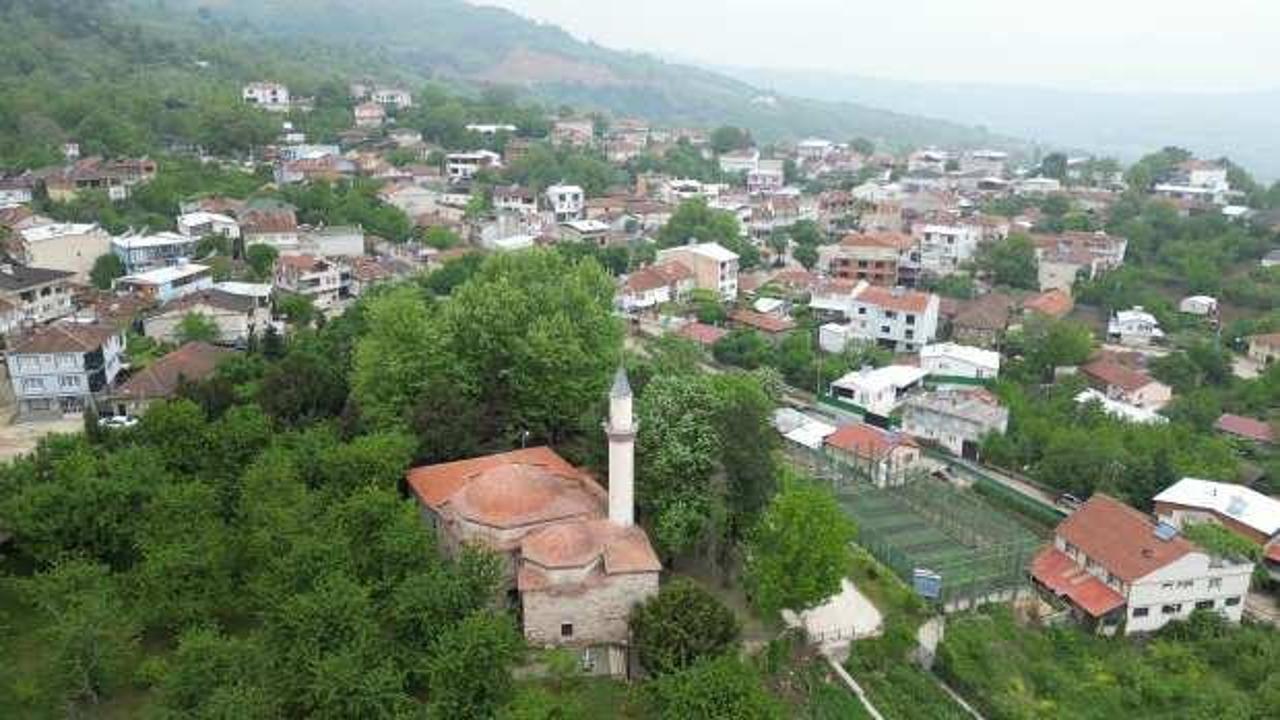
[902,388,1009,460]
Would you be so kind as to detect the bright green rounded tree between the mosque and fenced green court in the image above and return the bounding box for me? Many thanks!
[745,478,854,614]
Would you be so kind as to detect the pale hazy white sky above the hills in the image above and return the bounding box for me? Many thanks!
[474,0,1280,92]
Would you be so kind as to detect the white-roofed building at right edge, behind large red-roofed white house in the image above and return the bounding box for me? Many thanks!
[1155,478,1280,546]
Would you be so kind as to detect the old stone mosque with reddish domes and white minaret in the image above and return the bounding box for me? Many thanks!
[406,370,662,676]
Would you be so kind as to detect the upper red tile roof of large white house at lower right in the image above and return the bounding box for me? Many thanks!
[1056,493,1196,583]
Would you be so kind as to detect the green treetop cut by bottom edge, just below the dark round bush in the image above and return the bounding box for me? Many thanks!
[645,655,785,720]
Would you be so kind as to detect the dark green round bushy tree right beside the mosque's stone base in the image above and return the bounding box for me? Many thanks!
[631,578,741,675]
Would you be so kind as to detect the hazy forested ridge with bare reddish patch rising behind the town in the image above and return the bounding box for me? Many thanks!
[142,0,1018,146]
